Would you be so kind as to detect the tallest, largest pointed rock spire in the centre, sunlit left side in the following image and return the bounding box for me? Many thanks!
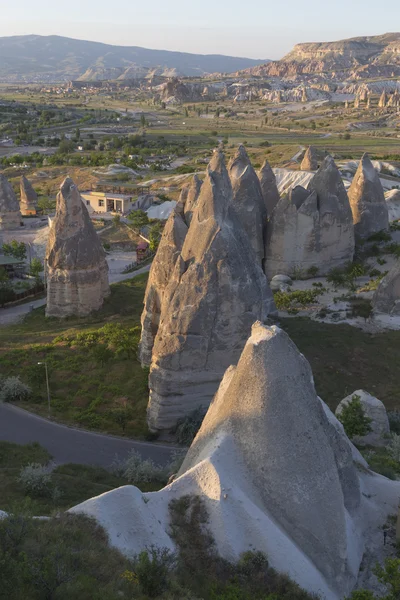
[148,152,275,430]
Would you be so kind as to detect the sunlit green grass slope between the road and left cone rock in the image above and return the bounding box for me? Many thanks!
[0,273,148,438]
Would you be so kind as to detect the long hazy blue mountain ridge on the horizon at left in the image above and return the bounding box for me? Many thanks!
[0,35,266,83]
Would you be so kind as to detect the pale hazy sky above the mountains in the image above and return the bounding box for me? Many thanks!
[0,0,400,59]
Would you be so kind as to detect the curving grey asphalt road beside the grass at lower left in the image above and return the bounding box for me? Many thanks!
[0,404,175,468]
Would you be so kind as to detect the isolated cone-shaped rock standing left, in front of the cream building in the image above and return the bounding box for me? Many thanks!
[46,177,110,317]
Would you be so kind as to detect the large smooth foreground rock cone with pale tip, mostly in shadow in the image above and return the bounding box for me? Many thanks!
[181,323,362,597]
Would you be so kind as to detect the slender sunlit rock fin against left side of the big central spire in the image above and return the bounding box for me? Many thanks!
[139,206,188,366]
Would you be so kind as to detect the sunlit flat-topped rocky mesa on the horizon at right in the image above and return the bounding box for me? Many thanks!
[247,33,400,80]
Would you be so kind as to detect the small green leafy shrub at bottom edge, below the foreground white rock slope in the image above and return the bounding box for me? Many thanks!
[133,546,176,598]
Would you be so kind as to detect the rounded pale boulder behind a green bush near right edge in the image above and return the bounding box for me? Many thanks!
[335,390,390,446]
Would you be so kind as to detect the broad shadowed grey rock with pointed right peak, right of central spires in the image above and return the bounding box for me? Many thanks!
[265,156,354,278]
